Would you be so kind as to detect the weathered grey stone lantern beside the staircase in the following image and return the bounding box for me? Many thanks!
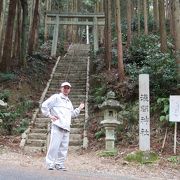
[99,91,122,151]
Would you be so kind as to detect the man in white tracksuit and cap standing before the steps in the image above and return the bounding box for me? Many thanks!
[41,82,84,170]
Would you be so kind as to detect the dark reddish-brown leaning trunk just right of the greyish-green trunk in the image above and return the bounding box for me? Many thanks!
[28,0,39,54]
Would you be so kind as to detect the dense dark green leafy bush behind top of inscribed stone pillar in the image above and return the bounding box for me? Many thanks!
[125,35,176,97]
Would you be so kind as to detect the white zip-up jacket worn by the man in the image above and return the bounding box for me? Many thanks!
[41,93,80,131]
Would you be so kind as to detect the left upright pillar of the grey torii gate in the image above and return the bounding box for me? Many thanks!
[51,15,59,56]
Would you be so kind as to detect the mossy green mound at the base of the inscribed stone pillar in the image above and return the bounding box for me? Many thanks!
[124,151,158,164]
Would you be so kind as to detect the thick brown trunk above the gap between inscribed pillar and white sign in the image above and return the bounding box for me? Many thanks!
[159,0,167,53]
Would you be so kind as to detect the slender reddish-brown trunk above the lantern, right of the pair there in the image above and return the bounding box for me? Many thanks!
[115,0,125,81]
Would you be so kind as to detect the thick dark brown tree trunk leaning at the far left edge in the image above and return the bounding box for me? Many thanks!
[0,0,17,72]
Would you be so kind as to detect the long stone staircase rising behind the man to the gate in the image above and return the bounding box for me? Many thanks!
[20,44,89,152]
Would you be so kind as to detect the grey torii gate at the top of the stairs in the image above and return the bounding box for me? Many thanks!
[45,12,105,56]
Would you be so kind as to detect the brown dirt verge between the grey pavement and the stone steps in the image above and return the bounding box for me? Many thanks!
[0,137,180,180]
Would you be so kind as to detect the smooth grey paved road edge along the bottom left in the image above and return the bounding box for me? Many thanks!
[0,164,135,180]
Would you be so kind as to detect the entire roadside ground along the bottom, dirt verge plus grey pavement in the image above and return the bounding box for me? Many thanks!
[0,149,180,180]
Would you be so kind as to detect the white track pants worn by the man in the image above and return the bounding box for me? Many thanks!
[46,125,70,166]
